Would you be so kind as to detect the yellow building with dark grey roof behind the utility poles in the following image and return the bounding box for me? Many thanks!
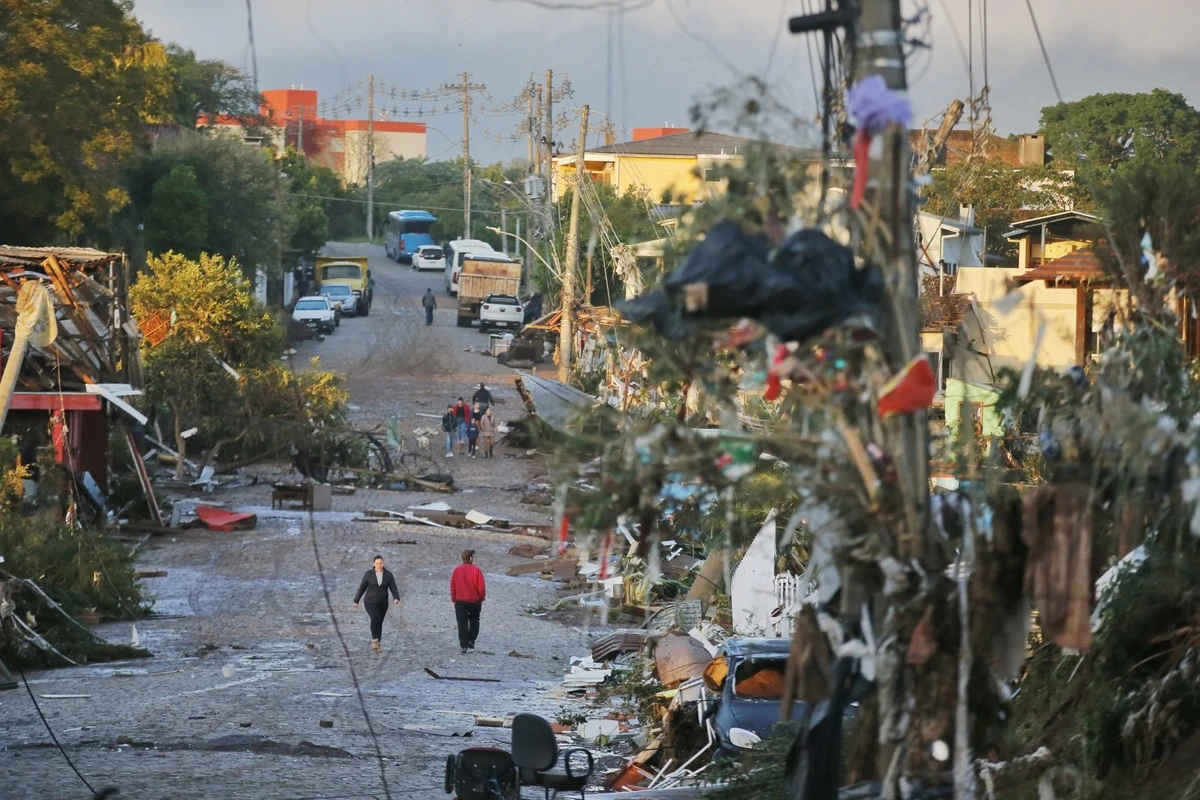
[552,128,820,205]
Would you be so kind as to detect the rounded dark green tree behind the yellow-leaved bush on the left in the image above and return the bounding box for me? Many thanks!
[128,133,289,275]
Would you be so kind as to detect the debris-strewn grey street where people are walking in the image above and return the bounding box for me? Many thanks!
[0,245,586,800]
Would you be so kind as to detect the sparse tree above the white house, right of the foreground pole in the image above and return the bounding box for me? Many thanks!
[924,158,1091,258]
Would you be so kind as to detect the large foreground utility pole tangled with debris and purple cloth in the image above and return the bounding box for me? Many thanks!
[852,0,945,800]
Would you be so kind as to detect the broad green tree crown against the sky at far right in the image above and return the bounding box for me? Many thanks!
[1042,89,1200,186]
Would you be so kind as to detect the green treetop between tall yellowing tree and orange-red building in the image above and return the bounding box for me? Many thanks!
[167,44,264,128]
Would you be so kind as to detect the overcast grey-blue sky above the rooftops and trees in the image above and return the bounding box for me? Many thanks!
[134,0,1200,161]
